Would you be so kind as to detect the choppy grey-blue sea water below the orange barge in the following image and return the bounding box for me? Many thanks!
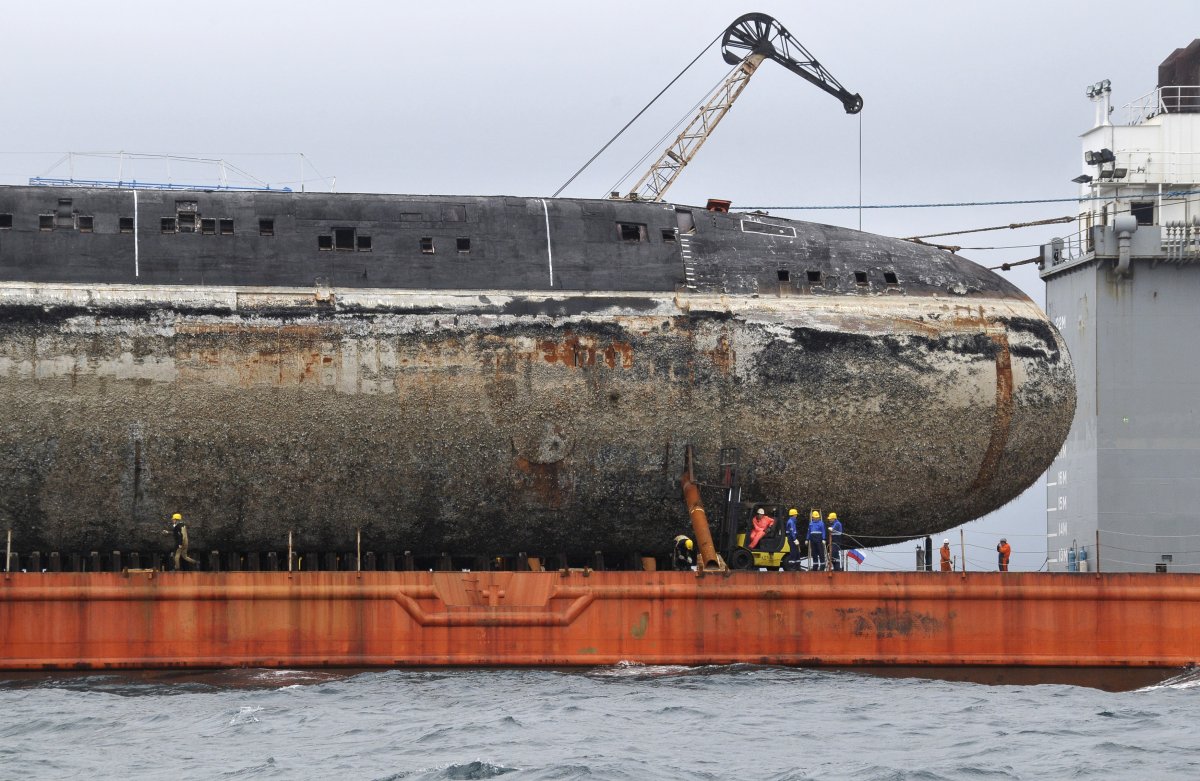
[0,666,1200,781]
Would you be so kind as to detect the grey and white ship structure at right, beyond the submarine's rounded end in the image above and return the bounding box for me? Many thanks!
[1040,40,1200,572]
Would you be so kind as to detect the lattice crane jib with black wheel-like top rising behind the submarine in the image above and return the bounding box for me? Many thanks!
[625,13,863,200]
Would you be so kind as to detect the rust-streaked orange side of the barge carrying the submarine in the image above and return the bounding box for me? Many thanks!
[0,570,1200,669]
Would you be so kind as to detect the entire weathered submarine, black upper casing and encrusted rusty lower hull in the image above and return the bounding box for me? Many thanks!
[0,188,1074,553]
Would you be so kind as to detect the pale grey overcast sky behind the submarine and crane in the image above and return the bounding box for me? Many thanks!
[0,0,1200,569]
